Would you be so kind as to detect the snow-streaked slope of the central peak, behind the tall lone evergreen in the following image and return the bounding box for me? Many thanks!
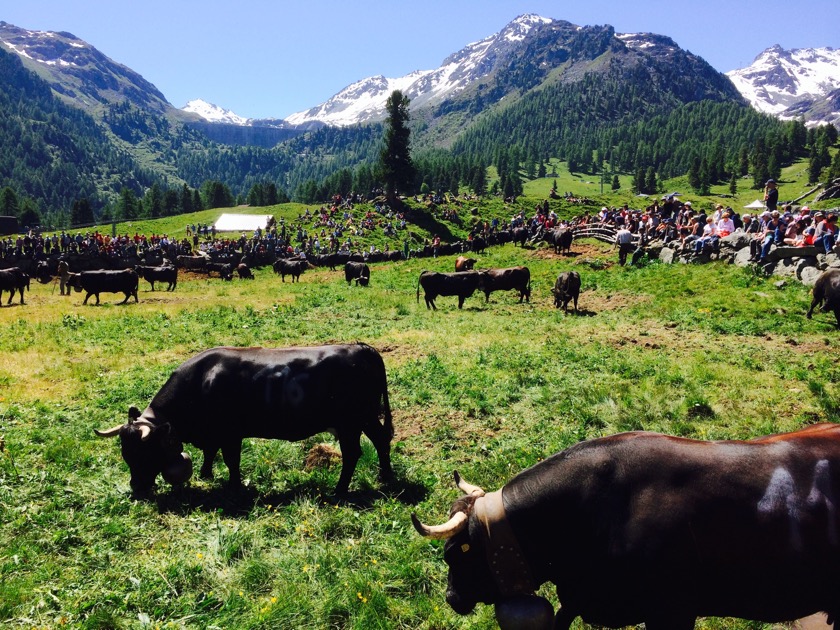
[285,15,554,126]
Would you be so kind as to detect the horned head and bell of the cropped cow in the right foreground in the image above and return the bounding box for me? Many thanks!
[411,472,554,630]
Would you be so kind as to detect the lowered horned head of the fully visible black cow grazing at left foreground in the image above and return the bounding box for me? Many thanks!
[94,407,192,493]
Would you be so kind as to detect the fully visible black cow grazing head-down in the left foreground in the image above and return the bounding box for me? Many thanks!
[96,343,394,494]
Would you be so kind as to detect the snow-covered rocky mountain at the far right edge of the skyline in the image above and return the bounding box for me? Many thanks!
[726,45,840,124]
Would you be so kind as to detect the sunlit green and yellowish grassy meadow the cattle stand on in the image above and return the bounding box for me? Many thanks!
[0,225,840,629]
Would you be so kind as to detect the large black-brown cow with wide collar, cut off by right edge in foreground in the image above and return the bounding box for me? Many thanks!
[412,424,840,630]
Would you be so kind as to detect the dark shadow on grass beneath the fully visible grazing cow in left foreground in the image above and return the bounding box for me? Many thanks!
[145,478,428,517]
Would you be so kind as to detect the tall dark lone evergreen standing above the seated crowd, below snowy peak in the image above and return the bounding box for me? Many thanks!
[379,90,414,206]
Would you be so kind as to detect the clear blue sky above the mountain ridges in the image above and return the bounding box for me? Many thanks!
[0,0,840,118]
